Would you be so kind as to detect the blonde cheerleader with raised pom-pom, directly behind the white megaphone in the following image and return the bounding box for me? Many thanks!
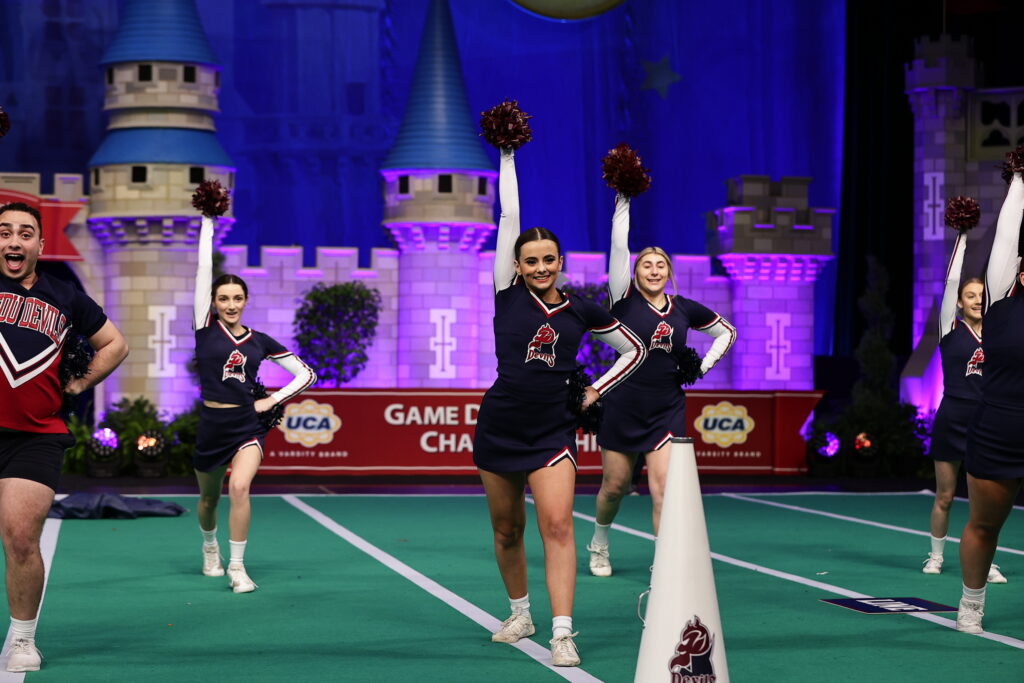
[587,145,736,577]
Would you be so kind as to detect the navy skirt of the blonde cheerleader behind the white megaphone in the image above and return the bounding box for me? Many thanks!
[597,383,686,453]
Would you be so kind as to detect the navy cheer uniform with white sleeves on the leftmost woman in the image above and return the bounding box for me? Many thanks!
[193,217,316,472]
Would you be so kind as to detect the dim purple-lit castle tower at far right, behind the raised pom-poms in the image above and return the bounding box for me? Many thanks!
[901,35,1024,411]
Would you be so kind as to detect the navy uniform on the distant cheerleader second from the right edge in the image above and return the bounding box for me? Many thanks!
[929,233,988,462]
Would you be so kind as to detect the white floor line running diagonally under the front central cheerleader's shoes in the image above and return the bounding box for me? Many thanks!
[282,495,601,683]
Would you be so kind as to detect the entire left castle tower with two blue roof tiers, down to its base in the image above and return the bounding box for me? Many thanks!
[88,0,234,413]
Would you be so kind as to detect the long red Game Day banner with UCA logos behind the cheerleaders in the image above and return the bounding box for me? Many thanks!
[261,389,821,475]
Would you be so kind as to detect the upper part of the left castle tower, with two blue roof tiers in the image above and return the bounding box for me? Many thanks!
[89,0,234,227]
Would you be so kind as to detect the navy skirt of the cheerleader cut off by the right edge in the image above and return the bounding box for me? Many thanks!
[966,403,1024,479]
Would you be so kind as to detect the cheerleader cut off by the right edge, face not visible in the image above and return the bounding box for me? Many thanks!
[956,152,1024,633]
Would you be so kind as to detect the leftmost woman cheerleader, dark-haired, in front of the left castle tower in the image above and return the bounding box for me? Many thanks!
[193,181,316,593]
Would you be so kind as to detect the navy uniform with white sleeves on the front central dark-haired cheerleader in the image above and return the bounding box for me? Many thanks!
[473,148,645,472]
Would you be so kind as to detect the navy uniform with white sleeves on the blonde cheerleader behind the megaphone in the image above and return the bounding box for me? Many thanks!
[597,195,736,453]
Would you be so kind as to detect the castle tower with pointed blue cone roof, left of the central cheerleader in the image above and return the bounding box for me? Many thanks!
[381,0,497,387]
